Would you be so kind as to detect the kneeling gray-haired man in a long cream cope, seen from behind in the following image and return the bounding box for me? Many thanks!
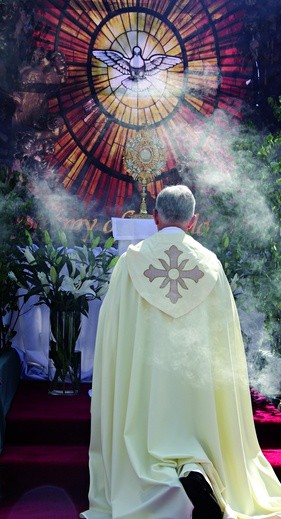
[80,185,281,519]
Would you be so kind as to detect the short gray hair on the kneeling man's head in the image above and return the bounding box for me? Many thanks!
[155,185,195,223]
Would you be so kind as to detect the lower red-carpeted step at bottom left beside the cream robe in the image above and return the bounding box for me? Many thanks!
[0,445,89,517]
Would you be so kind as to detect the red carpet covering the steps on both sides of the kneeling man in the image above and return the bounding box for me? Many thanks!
[0,381,281,519]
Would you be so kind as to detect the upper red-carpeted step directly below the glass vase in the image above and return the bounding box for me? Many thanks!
[5,380,91,445]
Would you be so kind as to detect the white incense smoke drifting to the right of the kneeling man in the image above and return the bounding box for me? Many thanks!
[176,110,281,396]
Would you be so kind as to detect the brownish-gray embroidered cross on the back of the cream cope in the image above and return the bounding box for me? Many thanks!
[144,245,204,304]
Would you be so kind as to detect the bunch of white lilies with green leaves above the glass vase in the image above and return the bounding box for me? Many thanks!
[9,230,118,316]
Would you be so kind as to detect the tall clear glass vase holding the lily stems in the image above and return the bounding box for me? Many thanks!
[48,308,81,395]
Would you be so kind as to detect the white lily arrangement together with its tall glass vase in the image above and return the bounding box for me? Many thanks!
[9,231,118,395]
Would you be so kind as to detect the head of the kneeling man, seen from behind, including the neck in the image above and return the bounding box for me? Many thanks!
[153,185,195,231]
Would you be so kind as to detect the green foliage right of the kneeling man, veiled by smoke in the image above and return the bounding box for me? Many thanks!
[197,116,281,356]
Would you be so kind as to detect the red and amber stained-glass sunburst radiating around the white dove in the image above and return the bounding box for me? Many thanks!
[35,0,245,216]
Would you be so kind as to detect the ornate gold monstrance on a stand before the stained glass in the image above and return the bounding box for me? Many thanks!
[124,130,165,218]
